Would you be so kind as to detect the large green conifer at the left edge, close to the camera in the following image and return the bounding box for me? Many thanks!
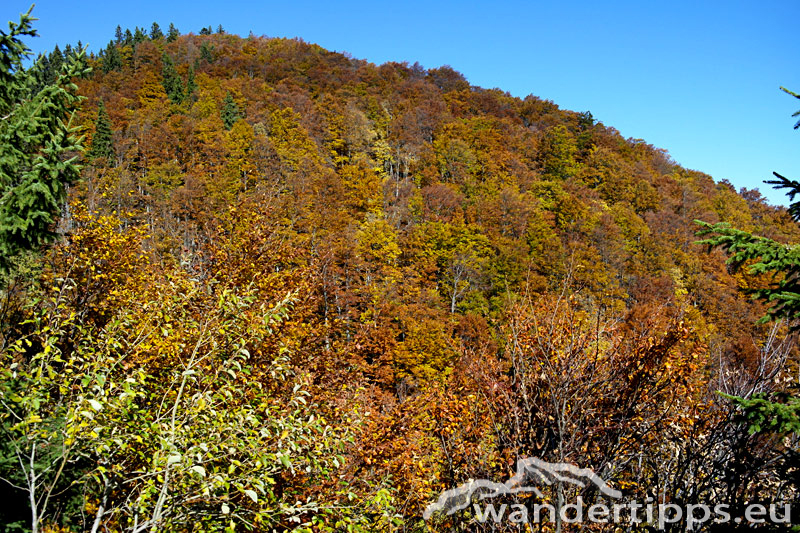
[0,10,84,268]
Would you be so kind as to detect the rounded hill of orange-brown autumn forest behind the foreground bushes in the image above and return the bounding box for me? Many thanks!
[75,29,798,350]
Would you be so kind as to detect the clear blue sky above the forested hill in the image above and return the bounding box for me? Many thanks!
[7,0,800,203]
